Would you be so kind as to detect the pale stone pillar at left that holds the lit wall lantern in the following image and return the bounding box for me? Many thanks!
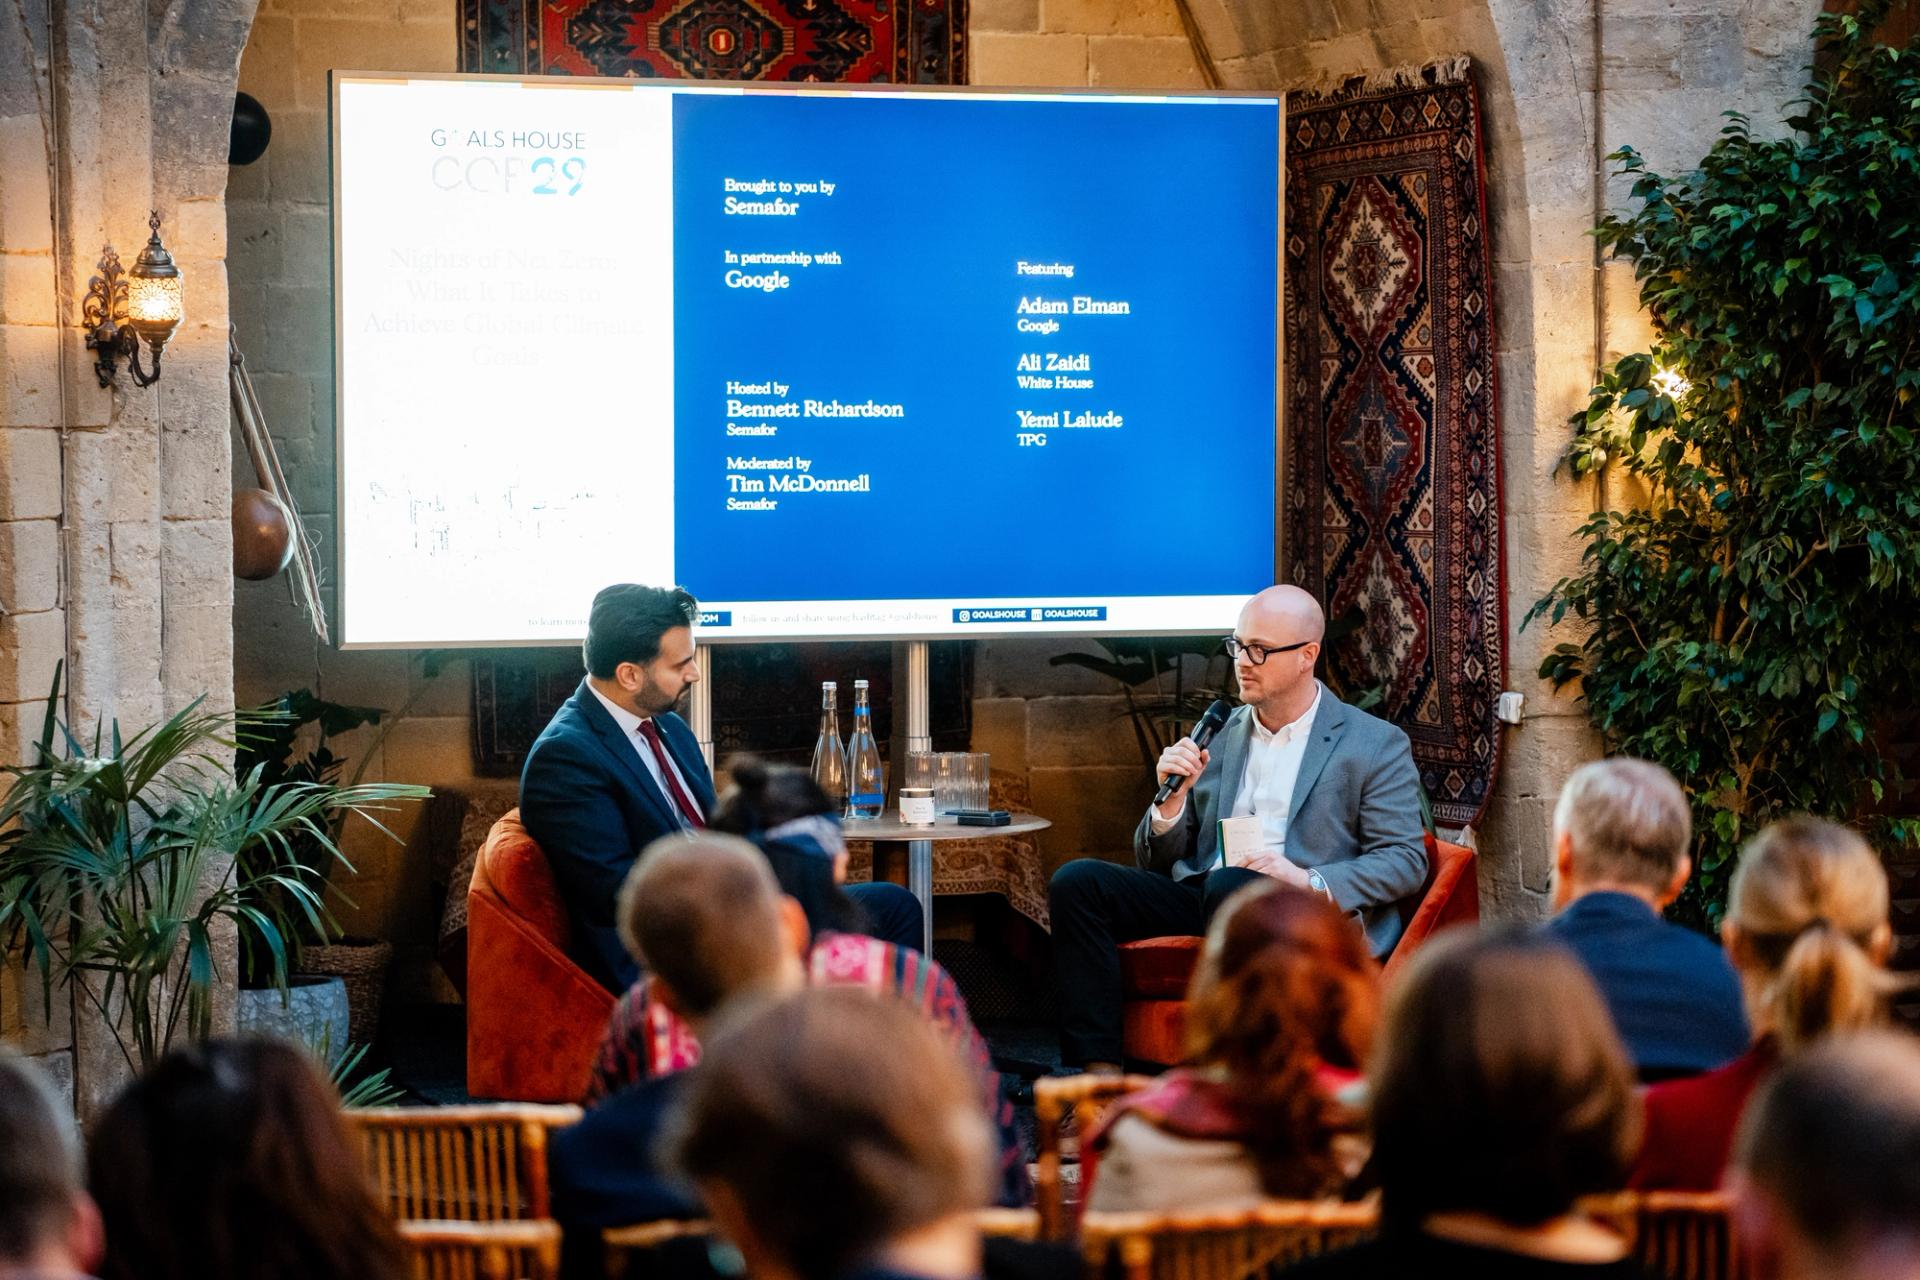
[0,0,253,1109]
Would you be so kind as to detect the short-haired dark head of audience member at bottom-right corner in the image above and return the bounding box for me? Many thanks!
[1734,1031,1920,1274]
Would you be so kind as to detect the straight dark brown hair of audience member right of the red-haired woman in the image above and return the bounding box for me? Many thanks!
[1373,929,1642,1230]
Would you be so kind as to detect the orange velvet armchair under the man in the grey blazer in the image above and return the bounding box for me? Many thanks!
[1119,835,1480,1065]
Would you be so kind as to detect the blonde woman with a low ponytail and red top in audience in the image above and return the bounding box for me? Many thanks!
[1632,818,1895,1190]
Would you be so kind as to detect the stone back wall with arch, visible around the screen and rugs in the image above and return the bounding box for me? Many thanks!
[217,0,1816,959]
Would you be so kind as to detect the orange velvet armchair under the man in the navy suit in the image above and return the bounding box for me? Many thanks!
[467,810,612,1102]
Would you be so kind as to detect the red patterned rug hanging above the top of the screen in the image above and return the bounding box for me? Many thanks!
[459,0,968,84]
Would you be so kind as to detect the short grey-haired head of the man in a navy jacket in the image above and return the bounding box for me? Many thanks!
[1553,756,1693,908]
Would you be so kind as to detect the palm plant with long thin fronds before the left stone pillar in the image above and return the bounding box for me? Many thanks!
[0,672,428,1071]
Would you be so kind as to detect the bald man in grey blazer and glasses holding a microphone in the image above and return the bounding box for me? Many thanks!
[1048,585,1427,1071]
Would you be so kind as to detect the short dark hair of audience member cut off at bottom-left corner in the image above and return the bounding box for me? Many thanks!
[0,1048,81,1263]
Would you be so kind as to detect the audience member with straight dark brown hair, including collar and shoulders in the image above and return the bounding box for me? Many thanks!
[1288,931,1640,1280]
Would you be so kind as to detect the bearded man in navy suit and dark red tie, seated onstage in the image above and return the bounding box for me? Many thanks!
[520,583,920,992]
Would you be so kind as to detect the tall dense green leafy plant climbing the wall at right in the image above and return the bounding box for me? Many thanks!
[1528,0,1920,925]
